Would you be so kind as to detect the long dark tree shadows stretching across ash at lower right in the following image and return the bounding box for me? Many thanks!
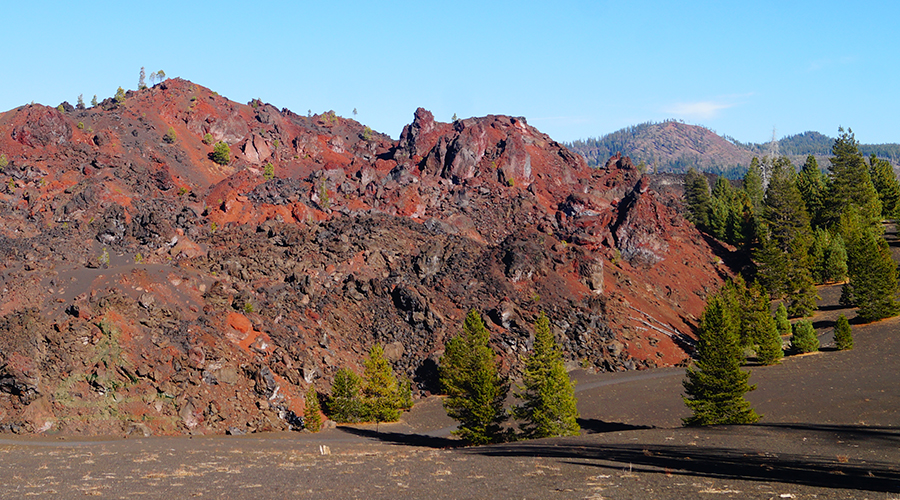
[465,424,900,492]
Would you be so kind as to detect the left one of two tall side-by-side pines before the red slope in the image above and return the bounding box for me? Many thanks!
[440,310,509,444]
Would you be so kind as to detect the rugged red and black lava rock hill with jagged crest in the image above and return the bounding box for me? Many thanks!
[0,79,729,435]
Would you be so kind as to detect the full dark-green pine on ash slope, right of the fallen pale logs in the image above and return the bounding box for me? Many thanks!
[683,295,760,425]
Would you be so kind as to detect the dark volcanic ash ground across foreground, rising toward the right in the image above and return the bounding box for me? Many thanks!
[0,287,900,499]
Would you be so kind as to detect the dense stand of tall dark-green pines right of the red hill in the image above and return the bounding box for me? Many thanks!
[685,129,900,321]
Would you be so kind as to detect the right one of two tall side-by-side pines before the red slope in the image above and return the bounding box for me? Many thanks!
[514,313,581,438]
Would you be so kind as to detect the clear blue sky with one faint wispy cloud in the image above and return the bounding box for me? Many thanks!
[0,0,900,143]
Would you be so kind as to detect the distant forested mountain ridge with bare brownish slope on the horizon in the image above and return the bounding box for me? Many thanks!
[566,120,900,177]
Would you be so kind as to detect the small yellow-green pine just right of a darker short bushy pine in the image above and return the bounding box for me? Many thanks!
[362,344,412,422]
